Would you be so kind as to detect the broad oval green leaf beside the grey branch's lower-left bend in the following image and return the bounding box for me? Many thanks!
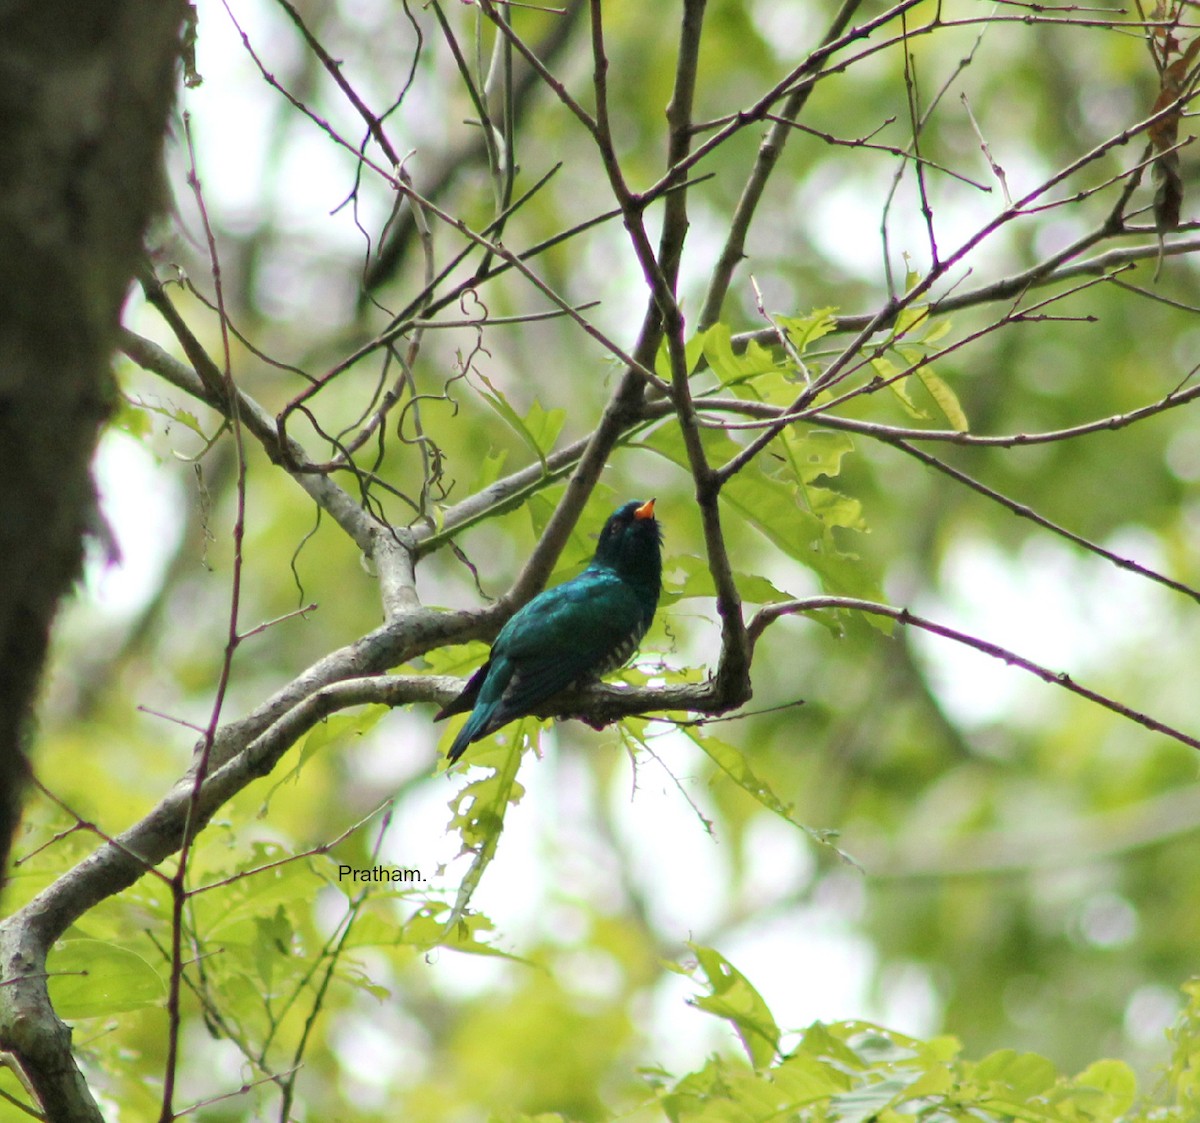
[46,939,167,1021]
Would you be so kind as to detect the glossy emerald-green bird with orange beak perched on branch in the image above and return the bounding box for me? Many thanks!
[434,499,662,763]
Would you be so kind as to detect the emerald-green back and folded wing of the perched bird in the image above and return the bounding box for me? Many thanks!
[487,570,647,729]
